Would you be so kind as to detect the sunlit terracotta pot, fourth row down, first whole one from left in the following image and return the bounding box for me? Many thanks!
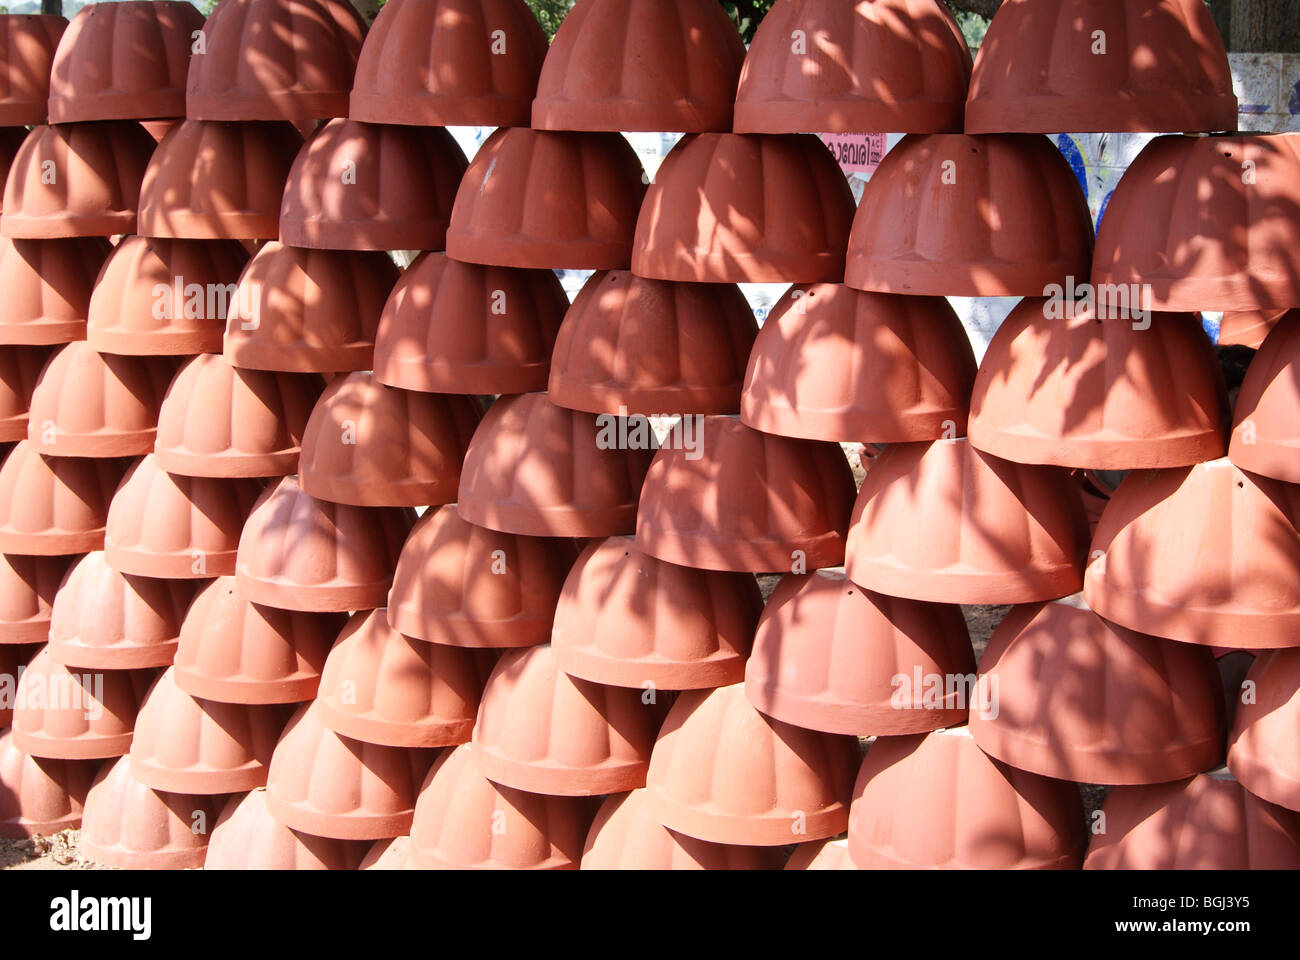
[27,341,174,457]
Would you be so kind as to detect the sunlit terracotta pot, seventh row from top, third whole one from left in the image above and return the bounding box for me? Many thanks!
[267,705,438,840]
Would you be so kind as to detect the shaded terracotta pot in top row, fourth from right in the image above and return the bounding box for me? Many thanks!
[348,0,546,126]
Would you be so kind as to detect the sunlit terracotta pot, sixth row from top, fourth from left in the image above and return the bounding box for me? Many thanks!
[316,610,497,747]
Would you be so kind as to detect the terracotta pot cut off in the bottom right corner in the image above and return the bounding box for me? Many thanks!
[1083,770,1300,870]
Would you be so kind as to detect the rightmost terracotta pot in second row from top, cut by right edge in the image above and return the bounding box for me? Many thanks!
[1092,134,1300,311]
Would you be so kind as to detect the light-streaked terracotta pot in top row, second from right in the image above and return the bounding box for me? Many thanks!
[736,0,971,133]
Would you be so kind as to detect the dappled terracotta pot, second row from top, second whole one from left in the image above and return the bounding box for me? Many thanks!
[139,119,304,239]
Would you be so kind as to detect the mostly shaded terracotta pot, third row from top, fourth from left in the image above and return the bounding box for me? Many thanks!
[374,252,569,394]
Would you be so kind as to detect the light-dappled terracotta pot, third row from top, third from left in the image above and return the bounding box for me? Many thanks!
[225,243,399,373]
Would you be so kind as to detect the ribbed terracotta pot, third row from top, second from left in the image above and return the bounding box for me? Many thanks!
[86,237,248,355]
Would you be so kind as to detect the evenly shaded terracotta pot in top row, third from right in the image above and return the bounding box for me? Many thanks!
[533,0,745,133]
